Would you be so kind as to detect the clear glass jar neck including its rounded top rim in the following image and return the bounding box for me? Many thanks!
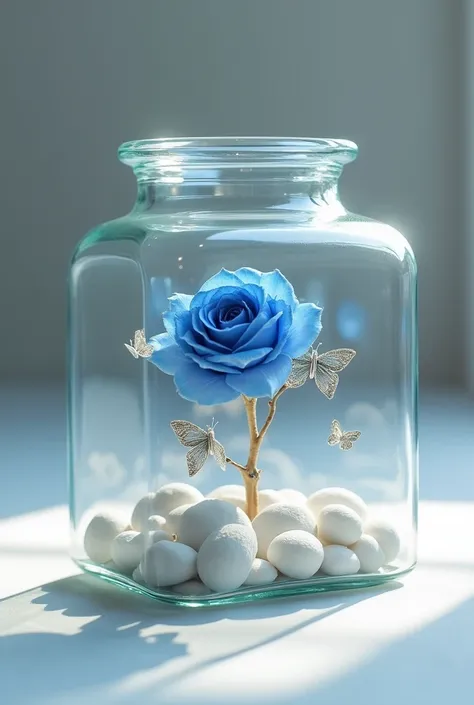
[119,137,357,219]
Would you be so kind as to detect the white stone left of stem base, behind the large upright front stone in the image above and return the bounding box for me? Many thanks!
[179,499,250,552]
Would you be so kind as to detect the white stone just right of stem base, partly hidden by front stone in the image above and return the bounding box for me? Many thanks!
[252,504,315,558]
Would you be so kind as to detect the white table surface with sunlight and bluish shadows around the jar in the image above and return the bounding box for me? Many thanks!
[0,388,474,705]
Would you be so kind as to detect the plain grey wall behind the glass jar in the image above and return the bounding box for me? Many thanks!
[0,0,462,384]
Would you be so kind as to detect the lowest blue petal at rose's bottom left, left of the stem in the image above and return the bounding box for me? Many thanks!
[174,362,239,406]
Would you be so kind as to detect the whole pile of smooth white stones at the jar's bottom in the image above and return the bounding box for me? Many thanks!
[84,483,400,595]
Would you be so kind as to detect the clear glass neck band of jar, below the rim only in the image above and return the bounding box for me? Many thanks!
[133,168,346,218]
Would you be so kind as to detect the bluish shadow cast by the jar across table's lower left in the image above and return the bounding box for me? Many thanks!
[0,575,400,705]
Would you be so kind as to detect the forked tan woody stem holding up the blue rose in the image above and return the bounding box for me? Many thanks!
[241,384,288,520]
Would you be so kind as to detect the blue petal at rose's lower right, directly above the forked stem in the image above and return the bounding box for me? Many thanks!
[227,355,291,397]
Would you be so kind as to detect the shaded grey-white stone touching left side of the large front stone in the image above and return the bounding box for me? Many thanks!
[140,541,197,587]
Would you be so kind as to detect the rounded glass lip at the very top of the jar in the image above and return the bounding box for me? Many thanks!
[118,136,358,168]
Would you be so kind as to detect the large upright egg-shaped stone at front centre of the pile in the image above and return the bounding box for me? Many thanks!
[197,523,257,592]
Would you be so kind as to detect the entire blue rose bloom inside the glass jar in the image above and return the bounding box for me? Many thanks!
[151,267,322,404]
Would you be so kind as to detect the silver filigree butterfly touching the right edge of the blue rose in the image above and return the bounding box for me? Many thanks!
[286,348,356,399]
